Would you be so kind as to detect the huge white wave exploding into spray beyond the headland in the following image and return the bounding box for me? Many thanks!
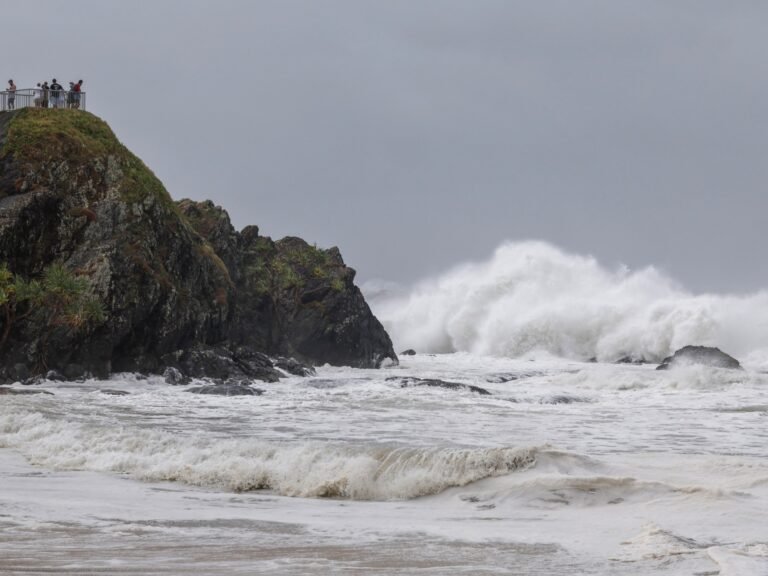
[366,242,768,361]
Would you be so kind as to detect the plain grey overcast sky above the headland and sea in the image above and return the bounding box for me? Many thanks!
[6,0,768,292]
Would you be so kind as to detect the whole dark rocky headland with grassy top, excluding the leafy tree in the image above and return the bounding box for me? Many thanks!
[0,109,396,379]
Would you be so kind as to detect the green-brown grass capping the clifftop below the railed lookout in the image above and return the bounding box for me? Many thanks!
[0,108,175,211]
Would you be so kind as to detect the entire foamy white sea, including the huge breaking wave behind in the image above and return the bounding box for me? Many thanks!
[0,242,768,576]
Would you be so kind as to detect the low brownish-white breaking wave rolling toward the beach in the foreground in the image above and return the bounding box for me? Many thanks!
[0,404,538,500]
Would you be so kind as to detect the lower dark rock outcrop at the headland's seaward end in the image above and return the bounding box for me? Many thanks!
[178,200,396,368]
